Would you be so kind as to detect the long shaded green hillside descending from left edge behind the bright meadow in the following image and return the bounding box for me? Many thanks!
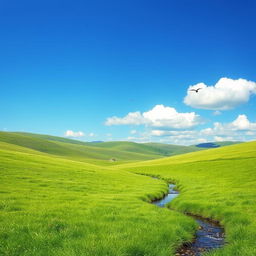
[0,132,161,164]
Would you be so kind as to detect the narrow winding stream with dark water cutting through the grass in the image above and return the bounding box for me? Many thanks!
[152,184,225,256]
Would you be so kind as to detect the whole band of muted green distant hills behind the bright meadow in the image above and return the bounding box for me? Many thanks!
[0,132,202,164]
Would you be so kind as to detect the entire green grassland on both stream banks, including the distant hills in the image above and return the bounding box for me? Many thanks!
[0,132,256,256]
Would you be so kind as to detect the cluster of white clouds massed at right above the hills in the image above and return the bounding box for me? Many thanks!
[105,77,256,145]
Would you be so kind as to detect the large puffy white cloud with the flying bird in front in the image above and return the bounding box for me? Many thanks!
[184,78,256,110]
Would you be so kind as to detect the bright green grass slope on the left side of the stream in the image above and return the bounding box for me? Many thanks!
[0,143,195,256]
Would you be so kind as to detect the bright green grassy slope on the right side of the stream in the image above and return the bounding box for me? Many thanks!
[119,142,256,256]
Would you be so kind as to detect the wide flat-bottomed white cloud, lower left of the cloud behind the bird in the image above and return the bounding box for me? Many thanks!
[105,105,202,129]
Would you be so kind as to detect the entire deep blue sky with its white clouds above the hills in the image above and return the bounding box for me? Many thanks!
[0,0,256,144]
